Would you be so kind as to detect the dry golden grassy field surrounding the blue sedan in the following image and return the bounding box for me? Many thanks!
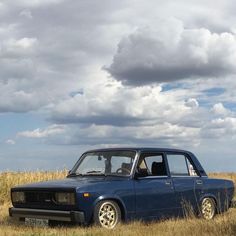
[0,171,236,236]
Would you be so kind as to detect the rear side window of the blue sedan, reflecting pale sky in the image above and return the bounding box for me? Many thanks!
[167,154,197,176]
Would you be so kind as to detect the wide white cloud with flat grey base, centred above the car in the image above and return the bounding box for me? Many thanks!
[51,82,197,126]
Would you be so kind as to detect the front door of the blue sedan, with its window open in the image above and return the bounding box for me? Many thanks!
[135,153,176,219]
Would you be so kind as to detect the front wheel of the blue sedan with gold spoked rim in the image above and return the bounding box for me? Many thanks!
[93,200,121,229]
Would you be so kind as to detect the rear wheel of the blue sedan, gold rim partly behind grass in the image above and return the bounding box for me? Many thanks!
[200,198,216,220]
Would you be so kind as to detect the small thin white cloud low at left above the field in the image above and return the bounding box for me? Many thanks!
[17,124,65,138]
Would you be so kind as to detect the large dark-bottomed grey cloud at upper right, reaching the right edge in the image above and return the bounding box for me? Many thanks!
[107,22,236,86]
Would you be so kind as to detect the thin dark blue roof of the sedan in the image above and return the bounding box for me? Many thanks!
[83,147,190,153]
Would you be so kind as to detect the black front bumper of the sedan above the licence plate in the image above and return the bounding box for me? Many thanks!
[9,207,85,223]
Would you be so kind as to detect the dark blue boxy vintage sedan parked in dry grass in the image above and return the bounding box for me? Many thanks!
[9,148,234,228]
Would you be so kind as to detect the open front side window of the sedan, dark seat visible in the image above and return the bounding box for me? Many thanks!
[138,154,167,176]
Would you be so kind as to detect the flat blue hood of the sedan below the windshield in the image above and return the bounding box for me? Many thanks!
[12,176,126,190]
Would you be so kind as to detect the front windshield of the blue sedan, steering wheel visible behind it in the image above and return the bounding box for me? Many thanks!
[71,151,136,176]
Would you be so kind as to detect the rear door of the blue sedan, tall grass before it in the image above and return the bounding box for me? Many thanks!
[166,153,202,215]
